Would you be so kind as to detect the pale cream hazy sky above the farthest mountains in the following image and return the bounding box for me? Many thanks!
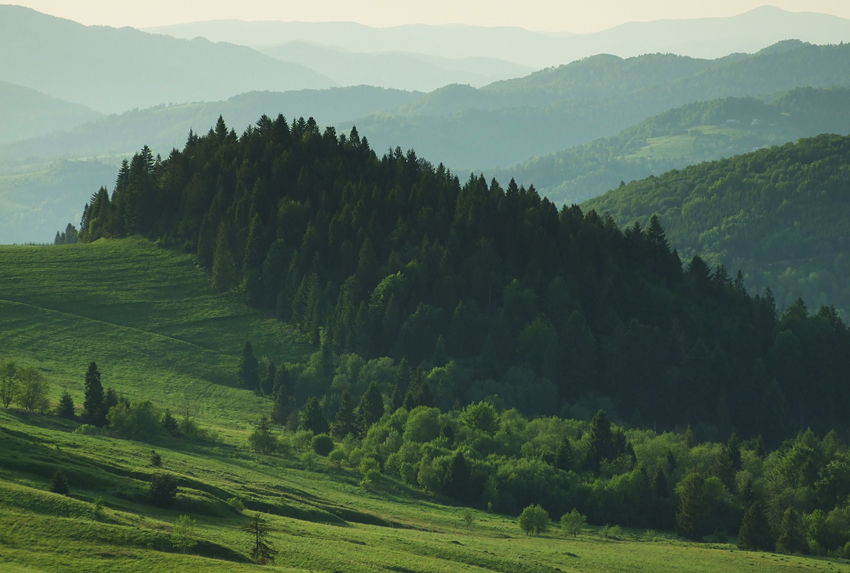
[4,0,850,33]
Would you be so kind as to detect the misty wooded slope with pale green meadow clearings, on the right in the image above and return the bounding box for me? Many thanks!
[494,88,850,204]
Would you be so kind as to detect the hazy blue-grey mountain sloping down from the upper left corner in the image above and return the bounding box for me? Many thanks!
[0,5,335,113]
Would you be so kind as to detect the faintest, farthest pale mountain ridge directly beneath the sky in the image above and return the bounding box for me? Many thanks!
[148,6,850,69]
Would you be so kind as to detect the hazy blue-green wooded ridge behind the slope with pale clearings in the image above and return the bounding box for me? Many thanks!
[352,42,850,170]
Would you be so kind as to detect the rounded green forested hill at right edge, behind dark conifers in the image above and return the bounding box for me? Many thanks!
[584,135,850,317]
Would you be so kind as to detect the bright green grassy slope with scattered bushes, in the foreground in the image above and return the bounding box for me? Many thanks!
[0,235,850,573]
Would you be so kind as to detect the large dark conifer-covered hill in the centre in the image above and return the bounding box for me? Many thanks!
[76,117,850,442]
